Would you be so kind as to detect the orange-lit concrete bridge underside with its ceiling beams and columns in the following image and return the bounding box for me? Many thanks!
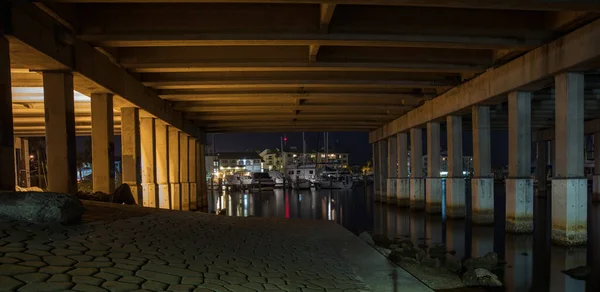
[0,0,600,244]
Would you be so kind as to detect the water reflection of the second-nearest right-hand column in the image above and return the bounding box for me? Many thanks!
[504,234,533,291]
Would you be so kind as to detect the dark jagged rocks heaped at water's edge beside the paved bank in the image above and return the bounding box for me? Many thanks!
[359,232,502,287]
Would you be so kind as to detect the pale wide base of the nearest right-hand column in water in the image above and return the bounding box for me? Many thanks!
[551,178,587,246]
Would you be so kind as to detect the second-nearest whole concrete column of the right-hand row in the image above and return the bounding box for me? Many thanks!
[505,91,533,233]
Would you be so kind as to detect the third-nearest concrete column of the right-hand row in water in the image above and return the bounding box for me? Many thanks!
[471,106,494,224]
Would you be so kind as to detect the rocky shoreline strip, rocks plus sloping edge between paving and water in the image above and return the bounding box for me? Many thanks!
[359,232,503,291]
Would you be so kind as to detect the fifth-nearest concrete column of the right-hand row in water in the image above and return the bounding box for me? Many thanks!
[425,122,442,214]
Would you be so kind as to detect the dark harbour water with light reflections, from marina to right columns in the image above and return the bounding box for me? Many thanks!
[209,184,600,292]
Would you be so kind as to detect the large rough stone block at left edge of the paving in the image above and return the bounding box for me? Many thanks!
[0,192,84,224]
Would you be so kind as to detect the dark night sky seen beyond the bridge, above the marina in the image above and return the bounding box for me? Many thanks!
[77,130,508,167]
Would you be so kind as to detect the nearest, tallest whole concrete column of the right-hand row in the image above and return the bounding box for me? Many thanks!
[551,73,587,246]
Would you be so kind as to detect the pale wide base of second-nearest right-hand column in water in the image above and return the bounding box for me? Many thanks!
[505,178,533,233]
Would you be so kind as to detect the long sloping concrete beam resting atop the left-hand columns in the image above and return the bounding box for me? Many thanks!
[3,1,202,138]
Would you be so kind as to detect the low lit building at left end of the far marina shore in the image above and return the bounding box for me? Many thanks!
[213,152,264,174]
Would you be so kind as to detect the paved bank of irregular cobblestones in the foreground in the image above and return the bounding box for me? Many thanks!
[0,202,432,291]
